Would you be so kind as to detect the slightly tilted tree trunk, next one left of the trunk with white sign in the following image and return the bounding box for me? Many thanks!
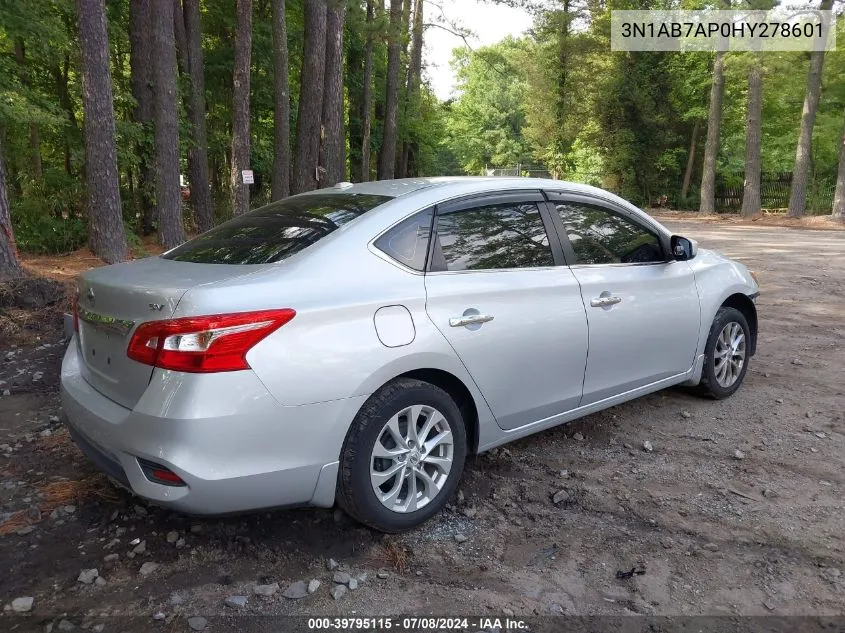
[182,0,214,233]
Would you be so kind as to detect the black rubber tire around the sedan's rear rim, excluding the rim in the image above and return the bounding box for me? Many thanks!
[337,378,467,534]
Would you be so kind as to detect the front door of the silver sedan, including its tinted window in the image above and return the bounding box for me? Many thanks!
[549,194,700,405]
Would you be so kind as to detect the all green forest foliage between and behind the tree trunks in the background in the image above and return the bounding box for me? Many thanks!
[0,0,845,262]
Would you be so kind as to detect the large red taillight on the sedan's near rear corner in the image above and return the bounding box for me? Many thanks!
[126,308,296,373]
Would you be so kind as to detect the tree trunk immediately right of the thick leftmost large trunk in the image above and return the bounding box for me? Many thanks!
[129,0,157,235]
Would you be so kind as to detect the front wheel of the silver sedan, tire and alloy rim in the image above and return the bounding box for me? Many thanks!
[699,307,751,400]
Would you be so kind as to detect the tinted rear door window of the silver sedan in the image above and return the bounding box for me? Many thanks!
[435,202,554,270]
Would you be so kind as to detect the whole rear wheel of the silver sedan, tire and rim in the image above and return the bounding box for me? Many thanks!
[337,379,466,532]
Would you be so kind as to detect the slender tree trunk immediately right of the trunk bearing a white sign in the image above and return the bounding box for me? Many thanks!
[270,0,290,200]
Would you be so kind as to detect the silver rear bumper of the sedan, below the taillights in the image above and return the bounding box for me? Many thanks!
[61,341,365,515]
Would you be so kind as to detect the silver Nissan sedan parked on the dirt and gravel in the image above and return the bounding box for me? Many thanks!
[61,178,758,532]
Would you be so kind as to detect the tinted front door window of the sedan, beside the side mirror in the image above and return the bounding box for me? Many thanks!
[555,202,666,264]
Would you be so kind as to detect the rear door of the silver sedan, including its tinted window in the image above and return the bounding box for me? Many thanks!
[425,191,587,429]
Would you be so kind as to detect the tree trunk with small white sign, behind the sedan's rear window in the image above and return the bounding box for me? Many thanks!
[231,0,252,215]
